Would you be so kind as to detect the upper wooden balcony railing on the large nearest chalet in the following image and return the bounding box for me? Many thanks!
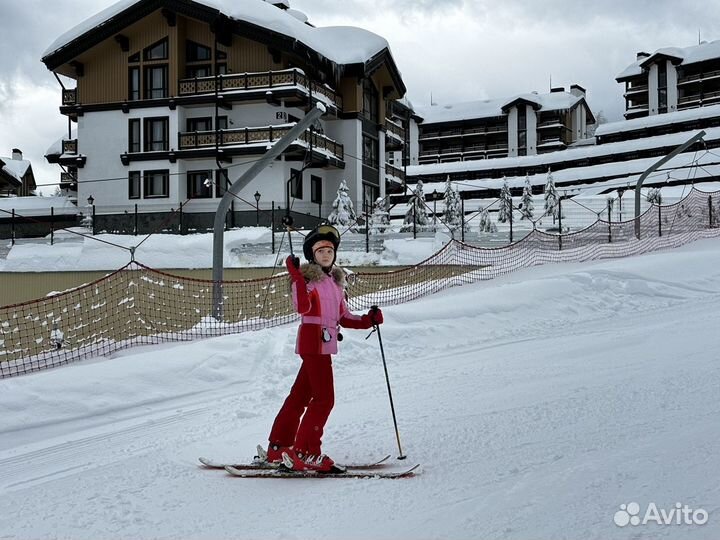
[179,68,342,110]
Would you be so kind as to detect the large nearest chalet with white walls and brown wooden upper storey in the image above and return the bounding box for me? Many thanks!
[42,0,408,228]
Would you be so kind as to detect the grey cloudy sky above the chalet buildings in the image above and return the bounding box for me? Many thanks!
[0,0,720,192]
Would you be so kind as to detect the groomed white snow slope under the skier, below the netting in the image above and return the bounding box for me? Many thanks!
[0,239,720,540]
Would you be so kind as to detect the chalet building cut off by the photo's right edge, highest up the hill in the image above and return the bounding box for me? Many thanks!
[615,41,720,120]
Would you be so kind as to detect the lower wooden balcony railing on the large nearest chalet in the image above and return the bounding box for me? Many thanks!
[178,124,345,160]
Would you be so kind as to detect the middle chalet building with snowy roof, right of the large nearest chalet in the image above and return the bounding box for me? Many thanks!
[414,85,595,164]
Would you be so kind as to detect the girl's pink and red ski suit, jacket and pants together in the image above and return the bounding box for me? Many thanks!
[270,263,373,456]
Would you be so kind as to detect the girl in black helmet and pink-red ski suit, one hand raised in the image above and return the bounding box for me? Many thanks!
[267,225,383,472]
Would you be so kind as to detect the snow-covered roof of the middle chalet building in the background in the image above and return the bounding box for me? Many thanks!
[415,92,583,124]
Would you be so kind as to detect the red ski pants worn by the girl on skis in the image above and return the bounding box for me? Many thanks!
[270,354,335,456]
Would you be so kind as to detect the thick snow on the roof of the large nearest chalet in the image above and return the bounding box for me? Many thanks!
[43,0,390,64]
